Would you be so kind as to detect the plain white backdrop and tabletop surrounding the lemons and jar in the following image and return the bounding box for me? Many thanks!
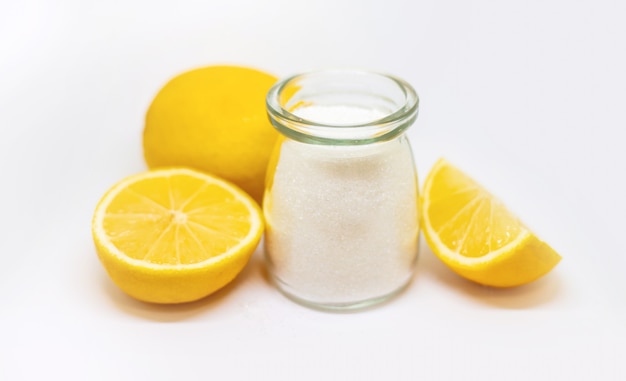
[0,0,626,380]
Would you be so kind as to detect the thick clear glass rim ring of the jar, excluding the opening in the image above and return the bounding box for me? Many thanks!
[266,69,419,144]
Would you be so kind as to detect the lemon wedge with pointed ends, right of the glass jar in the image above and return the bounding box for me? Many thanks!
[420,159,561,287]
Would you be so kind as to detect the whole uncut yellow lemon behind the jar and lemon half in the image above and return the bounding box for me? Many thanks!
[143,66,278,203]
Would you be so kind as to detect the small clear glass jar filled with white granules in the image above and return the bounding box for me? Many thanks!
[263,70,419,309]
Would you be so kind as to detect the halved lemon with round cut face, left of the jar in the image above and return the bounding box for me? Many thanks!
[92,168,263,303]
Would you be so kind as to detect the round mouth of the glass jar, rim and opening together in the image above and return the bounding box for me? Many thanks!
[266,69,419,145]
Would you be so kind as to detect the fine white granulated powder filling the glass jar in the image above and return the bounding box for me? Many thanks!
[264,107,419,306]
